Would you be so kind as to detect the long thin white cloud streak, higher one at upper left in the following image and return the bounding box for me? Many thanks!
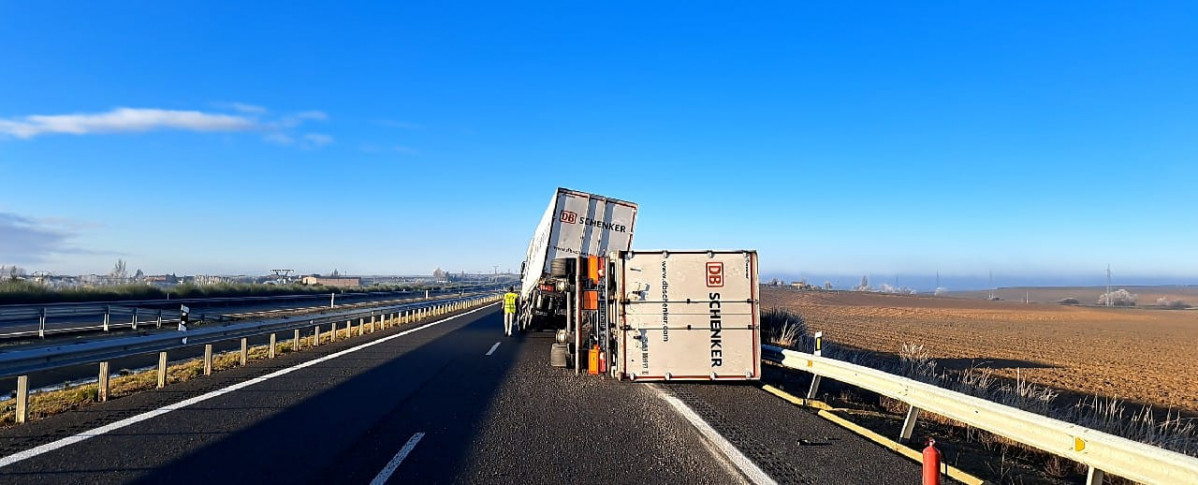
[0,108,259,138]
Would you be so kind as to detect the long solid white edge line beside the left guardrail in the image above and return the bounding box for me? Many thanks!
[0,304,495,468]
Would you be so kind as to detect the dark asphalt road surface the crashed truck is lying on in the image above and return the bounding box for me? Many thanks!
[0,305,919,485]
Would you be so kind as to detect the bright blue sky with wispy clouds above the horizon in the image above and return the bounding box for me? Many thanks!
[0,1,1198,287]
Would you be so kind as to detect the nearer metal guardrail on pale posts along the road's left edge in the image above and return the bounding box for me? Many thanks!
[0,293,498,423]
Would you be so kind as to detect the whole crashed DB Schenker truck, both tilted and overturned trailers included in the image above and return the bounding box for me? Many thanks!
[520,189,761,381]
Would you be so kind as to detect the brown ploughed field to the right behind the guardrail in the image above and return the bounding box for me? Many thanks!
[762,287,1198,413]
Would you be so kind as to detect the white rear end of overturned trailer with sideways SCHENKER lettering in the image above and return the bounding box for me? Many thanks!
[612,250,761,381]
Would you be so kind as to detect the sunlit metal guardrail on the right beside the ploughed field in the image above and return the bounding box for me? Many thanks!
[762,345,1198,485]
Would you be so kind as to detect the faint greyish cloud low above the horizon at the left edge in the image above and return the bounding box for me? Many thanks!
[0,212,111,263]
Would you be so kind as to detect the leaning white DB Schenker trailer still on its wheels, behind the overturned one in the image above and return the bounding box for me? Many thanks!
[519,188,636,328]
